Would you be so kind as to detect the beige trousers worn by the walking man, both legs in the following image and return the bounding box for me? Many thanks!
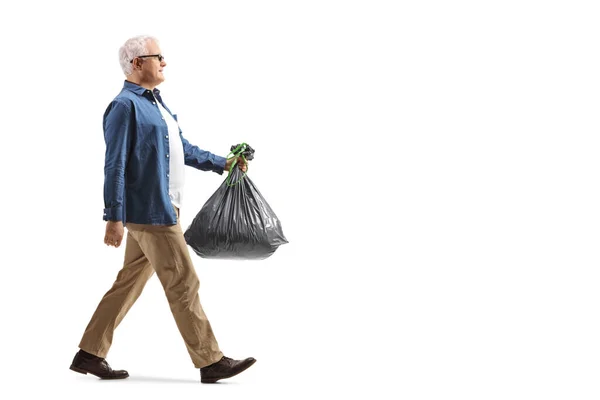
[79,209,223,368]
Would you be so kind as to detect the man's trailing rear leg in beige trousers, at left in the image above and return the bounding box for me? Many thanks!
[79,232,154,358]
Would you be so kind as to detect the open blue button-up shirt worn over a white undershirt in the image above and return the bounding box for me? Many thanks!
[103,81,227,225]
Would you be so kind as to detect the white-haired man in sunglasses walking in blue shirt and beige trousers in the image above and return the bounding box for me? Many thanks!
[71,36,256,383]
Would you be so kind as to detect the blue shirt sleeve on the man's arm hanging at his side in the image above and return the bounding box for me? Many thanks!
[103,100,135,221]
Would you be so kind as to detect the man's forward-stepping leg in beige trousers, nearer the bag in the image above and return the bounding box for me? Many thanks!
[130,221,223,368]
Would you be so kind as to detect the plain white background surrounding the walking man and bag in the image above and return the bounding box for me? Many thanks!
[0,0,600,400]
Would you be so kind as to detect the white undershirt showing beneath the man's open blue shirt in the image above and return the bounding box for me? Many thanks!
[156,96,185,208]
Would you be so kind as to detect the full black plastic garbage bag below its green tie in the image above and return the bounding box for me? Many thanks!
[184,164,288,260]
